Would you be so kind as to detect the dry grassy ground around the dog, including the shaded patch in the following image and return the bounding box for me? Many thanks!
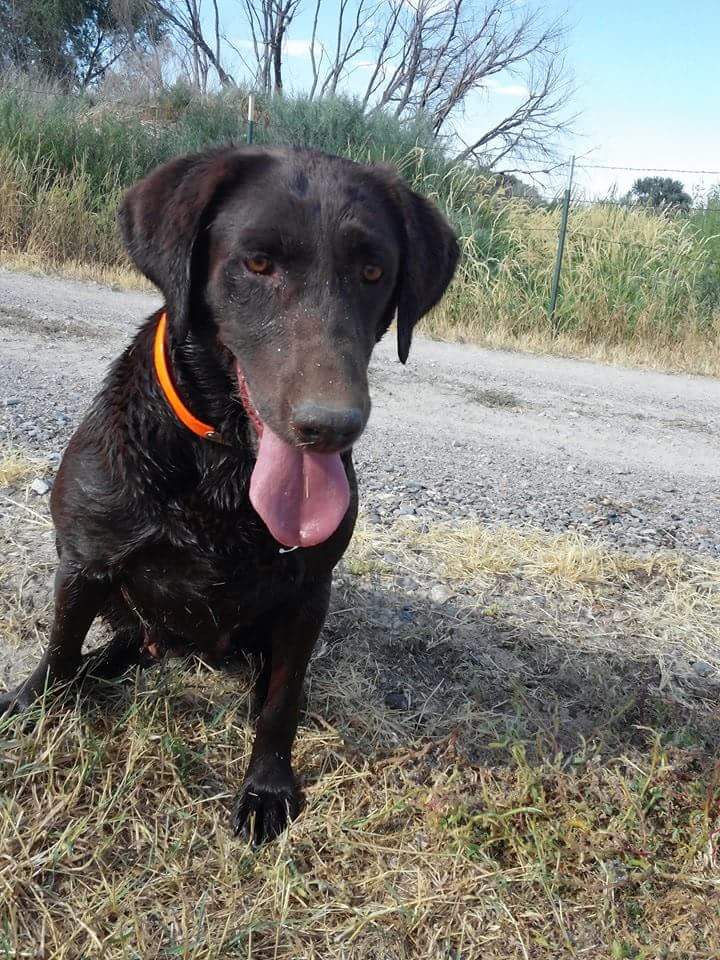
[0,492,720,960]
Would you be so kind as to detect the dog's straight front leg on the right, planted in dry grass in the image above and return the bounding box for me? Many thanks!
[232,580,330,845]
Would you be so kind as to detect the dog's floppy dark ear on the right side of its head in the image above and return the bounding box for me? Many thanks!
[394,179,460,363]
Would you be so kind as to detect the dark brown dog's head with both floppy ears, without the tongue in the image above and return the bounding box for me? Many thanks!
[120,147,458,544]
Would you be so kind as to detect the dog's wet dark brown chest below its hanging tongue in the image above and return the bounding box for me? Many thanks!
[103,466,357,655]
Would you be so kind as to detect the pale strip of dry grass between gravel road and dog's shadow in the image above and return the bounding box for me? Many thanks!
[346,521,720,664]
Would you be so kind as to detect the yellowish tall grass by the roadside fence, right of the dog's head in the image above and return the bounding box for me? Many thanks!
[422,171,720,376]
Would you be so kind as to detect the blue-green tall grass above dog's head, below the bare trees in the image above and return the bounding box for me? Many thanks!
[0,79,447,199]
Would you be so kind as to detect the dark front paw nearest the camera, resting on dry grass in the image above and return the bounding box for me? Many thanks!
[232,769,300,847]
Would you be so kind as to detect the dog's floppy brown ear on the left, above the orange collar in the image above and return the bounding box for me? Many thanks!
[118,147,269,341]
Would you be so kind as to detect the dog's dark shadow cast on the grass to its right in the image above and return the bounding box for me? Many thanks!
[308,568,720,763]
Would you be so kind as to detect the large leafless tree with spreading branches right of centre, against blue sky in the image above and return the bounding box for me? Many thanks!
[296,0,572,166]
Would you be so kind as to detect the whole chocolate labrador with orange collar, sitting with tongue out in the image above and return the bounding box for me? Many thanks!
[0,147,458,843]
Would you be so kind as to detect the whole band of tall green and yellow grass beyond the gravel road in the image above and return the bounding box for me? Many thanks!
[0,82,720,375]
